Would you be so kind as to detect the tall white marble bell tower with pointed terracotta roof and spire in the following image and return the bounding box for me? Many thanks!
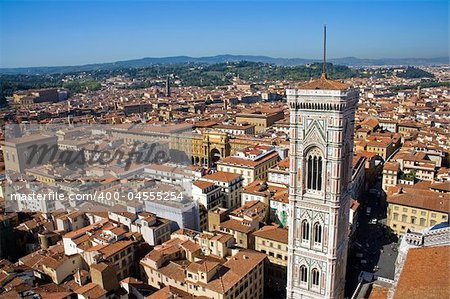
[286,28,359,299]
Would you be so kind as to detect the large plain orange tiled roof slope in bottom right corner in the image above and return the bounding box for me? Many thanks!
[394,246,450,299]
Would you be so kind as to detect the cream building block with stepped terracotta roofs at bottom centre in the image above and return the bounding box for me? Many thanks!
[141,238,266,299]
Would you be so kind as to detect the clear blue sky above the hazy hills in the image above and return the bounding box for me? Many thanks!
[0,0,449,67]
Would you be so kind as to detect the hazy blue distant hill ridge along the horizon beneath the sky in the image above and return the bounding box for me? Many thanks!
[0,55,449,75]
